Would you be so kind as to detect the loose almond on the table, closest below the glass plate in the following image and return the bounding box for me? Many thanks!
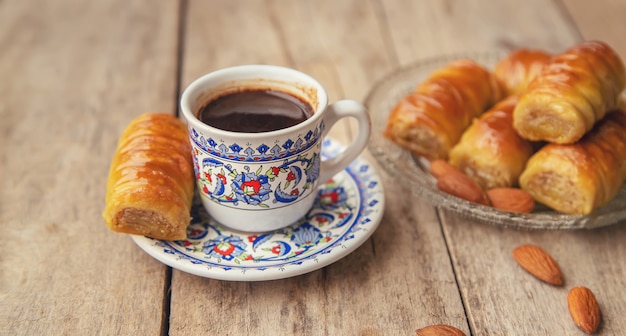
[513,244,563,286]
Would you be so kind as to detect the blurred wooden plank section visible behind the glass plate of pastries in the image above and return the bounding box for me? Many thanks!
[382,0,578,65]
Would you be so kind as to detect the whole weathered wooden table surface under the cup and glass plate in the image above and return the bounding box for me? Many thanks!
[0,0,626,335]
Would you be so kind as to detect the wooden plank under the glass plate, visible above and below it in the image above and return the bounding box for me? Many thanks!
[376,1,626,335]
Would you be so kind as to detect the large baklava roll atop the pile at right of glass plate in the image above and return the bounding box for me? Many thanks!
[513,41,626,144]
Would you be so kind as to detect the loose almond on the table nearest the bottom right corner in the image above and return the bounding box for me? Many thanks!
[567,286,601,334]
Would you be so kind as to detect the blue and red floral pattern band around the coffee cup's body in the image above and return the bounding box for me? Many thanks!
[190,123,324,208]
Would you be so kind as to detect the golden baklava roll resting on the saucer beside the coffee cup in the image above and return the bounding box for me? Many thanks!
[103,113,195,240]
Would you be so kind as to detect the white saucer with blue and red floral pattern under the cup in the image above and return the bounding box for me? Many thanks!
[131,139,384,281]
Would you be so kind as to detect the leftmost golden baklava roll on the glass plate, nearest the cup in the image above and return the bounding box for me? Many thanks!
[384,59,501,159]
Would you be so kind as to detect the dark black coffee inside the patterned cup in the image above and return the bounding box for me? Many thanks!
[198,88,314,133]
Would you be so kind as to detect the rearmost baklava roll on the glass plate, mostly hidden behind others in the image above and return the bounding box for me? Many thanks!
[493,49,552,96]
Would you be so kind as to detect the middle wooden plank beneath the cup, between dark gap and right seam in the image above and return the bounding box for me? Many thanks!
[171,1,468,335]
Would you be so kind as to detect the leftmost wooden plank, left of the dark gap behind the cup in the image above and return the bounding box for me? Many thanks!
[0,0,178,335]
